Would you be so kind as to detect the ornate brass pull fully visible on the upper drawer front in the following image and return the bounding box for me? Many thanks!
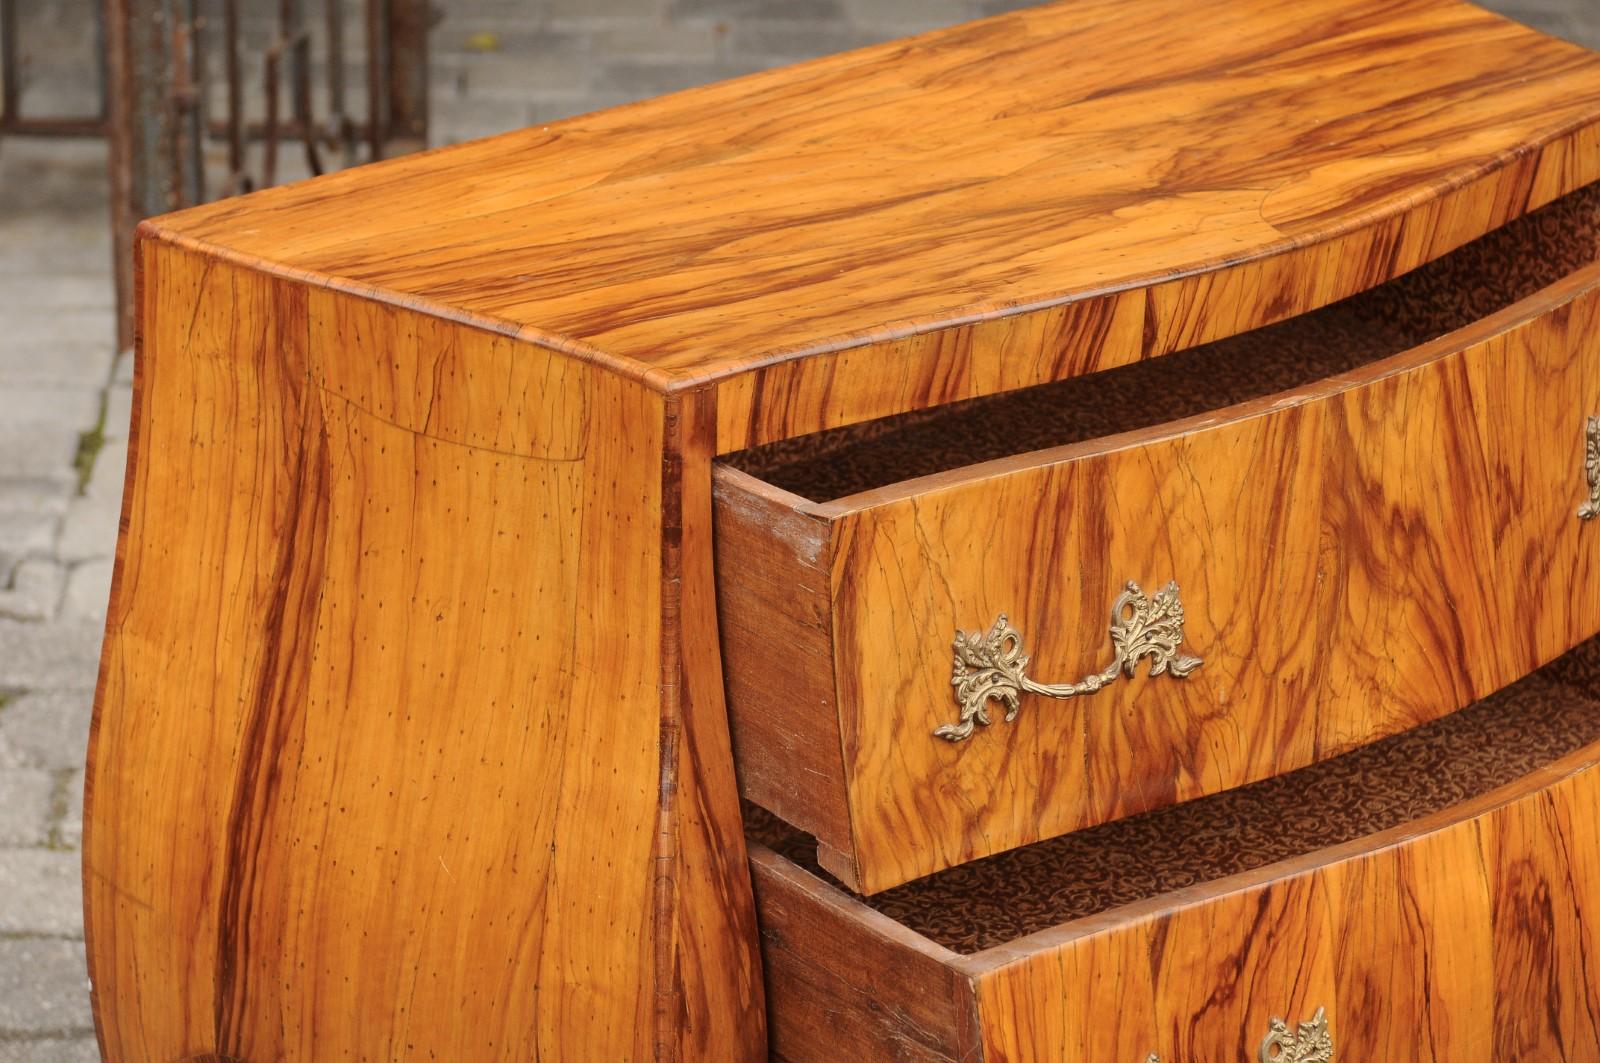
[933,580,1200,741]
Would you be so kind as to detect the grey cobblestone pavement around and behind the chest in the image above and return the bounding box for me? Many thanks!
[0,0,1600,1063]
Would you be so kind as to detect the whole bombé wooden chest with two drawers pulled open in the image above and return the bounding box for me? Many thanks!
[85,0,1600,1063]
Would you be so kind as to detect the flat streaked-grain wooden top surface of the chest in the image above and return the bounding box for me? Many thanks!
[146,0,1600,384]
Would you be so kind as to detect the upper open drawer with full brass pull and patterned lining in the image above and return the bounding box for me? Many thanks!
[715,180,1600,893]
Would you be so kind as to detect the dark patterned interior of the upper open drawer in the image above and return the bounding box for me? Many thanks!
[723,186,1600,503]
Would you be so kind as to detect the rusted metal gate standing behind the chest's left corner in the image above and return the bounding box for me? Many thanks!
[0,0,430,344]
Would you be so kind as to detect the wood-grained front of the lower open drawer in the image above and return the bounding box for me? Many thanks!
[978,755,1600,1063]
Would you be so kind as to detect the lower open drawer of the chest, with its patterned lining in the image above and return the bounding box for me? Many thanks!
[749,642,1600,1063]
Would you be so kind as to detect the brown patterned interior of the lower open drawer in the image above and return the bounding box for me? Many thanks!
[746,637,1600,954]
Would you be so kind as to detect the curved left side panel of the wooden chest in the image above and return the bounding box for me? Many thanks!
[85,239,763,1063]
